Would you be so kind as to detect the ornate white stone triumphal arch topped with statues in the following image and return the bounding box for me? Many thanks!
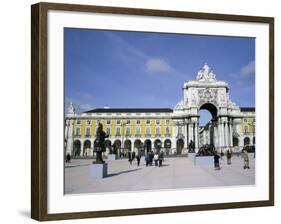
[174,64,246,151]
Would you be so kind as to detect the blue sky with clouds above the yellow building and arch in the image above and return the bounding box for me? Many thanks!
[64,28,255,125]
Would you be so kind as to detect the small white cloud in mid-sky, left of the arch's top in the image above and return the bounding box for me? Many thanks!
[145,58,174,74]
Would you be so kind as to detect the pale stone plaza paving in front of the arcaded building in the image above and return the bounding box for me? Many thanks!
[65,155,255,194]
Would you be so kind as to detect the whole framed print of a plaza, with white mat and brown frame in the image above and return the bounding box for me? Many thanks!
[31,3,274,221]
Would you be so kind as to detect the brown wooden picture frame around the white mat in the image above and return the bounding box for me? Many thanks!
[31,3,274,221]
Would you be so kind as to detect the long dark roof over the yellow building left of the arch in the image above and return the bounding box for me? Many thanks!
[84,108,173,113]
